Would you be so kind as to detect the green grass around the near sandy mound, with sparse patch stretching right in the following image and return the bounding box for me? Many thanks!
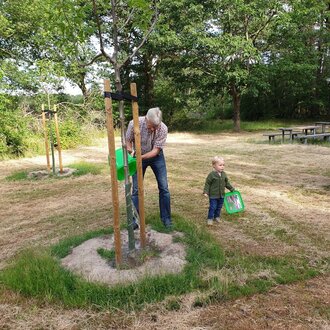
[0,216,318,310]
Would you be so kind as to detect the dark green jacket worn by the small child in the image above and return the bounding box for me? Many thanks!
[204,171,235,198]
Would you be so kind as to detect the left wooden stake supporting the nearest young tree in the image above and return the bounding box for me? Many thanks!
[104,79,122,267]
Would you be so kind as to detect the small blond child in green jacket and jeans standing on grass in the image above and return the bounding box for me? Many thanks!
[204,156,235,225]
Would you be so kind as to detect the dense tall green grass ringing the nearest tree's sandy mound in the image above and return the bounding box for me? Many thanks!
[0,217,224,309]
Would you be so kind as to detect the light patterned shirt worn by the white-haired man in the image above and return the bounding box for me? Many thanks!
[126,116,168,155]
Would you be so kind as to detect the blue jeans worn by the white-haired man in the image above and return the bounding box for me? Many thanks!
[132,151,172,227]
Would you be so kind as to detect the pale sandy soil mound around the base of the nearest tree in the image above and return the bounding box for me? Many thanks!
[61,229,186,285]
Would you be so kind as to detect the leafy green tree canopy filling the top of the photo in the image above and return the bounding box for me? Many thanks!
[0,0,330,131]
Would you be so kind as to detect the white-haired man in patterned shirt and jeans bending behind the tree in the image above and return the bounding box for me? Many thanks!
[126,108,172,229]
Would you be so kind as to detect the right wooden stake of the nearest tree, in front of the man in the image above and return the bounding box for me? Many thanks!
[131,83,146,248]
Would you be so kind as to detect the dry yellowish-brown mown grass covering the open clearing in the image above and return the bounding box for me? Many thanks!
[0,133,330,330]
